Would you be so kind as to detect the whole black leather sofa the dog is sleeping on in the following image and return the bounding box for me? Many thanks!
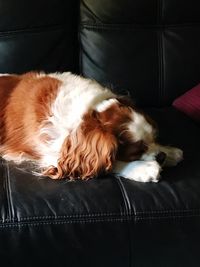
[0,0,200,267]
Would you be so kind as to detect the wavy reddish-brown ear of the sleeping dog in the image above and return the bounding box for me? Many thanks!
[58,114,117,180]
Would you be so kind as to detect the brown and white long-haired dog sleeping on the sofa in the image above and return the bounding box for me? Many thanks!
[0,72,182,182]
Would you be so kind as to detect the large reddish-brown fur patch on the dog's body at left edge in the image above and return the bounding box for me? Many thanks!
[0,73,60,159]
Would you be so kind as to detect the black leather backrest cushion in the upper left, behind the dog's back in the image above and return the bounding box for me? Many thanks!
[0,0,78,73]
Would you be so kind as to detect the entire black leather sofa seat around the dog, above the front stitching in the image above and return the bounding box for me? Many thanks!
[0,107,200,224]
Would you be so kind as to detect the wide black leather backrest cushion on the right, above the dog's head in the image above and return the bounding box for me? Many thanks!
[80,0,200,106]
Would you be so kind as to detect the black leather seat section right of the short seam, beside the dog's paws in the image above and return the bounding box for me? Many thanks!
[123,107,200,219]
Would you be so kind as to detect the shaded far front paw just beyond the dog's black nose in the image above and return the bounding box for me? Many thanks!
[164,147,183,166]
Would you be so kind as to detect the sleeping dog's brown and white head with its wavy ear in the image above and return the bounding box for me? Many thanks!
[45,98,156,179]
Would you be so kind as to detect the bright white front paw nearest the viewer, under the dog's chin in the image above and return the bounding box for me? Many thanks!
[113,161,161,183]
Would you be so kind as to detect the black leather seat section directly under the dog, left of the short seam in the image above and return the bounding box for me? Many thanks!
[1,162,125,224]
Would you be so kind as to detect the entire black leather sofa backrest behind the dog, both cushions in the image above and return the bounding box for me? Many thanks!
[0,0,200,106]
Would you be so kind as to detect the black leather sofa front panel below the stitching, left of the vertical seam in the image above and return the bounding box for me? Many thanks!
[0,220,130,267]
